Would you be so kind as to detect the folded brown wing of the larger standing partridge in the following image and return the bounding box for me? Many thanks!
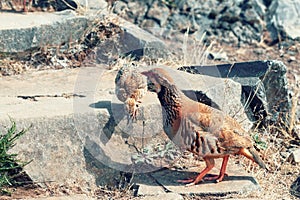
[181,104,252,156]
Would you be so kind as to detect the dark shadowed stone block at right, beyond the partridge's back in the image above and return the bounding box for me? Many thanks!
[179,61,291,124]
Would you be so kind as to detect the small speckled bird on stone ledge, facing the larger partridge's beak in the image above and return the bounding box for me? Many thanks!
[115,65,147,119]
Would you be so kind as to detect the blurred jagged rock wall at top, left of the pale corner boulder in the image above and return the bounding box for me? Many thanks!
[114,0,266,43]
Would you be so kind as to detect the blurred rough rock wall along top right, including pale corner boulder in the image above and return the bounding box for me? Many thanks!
[114,0,299,44]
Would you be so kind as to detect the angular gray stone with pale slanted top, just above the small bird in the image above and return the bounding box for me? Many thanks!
[95,18,169,64]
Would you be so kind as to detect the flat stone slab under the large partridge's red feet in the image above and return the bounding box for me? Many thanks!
[153,159,260,195]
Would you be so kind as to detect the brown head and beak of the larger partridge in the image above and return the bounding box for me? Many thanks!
[141,68,174,93]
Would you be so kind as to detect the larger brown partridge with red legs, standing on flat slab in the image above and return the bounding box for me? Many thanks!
[142,68,266,186]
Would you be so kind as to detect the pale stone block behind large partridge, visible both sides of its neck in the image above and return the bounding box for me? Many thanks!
[113,66,252,138]
